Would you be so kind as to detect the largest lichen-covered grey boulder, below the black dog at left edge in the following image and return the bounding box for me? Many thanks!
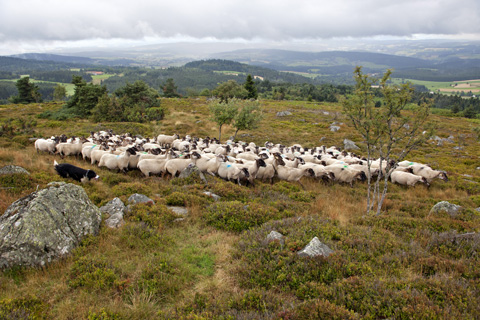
[0,182,101,268]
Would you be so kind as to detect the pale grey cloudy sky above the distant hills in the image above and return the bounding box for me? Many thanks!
[0,0,480,55]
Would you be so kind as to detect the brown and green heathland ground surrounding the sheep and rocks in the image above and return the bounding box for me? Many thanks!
[0,99,480,319]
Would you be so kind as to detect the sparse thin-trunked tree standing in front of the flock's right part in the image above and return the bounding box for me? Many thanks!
[343,67,431,215]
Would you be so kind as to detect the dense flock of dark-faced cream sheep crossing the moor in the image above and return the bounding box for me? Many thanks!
[35,131,448,187]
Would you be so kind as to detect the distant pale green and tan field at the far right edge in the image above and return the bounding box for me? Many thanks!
[392,78,480,95]
